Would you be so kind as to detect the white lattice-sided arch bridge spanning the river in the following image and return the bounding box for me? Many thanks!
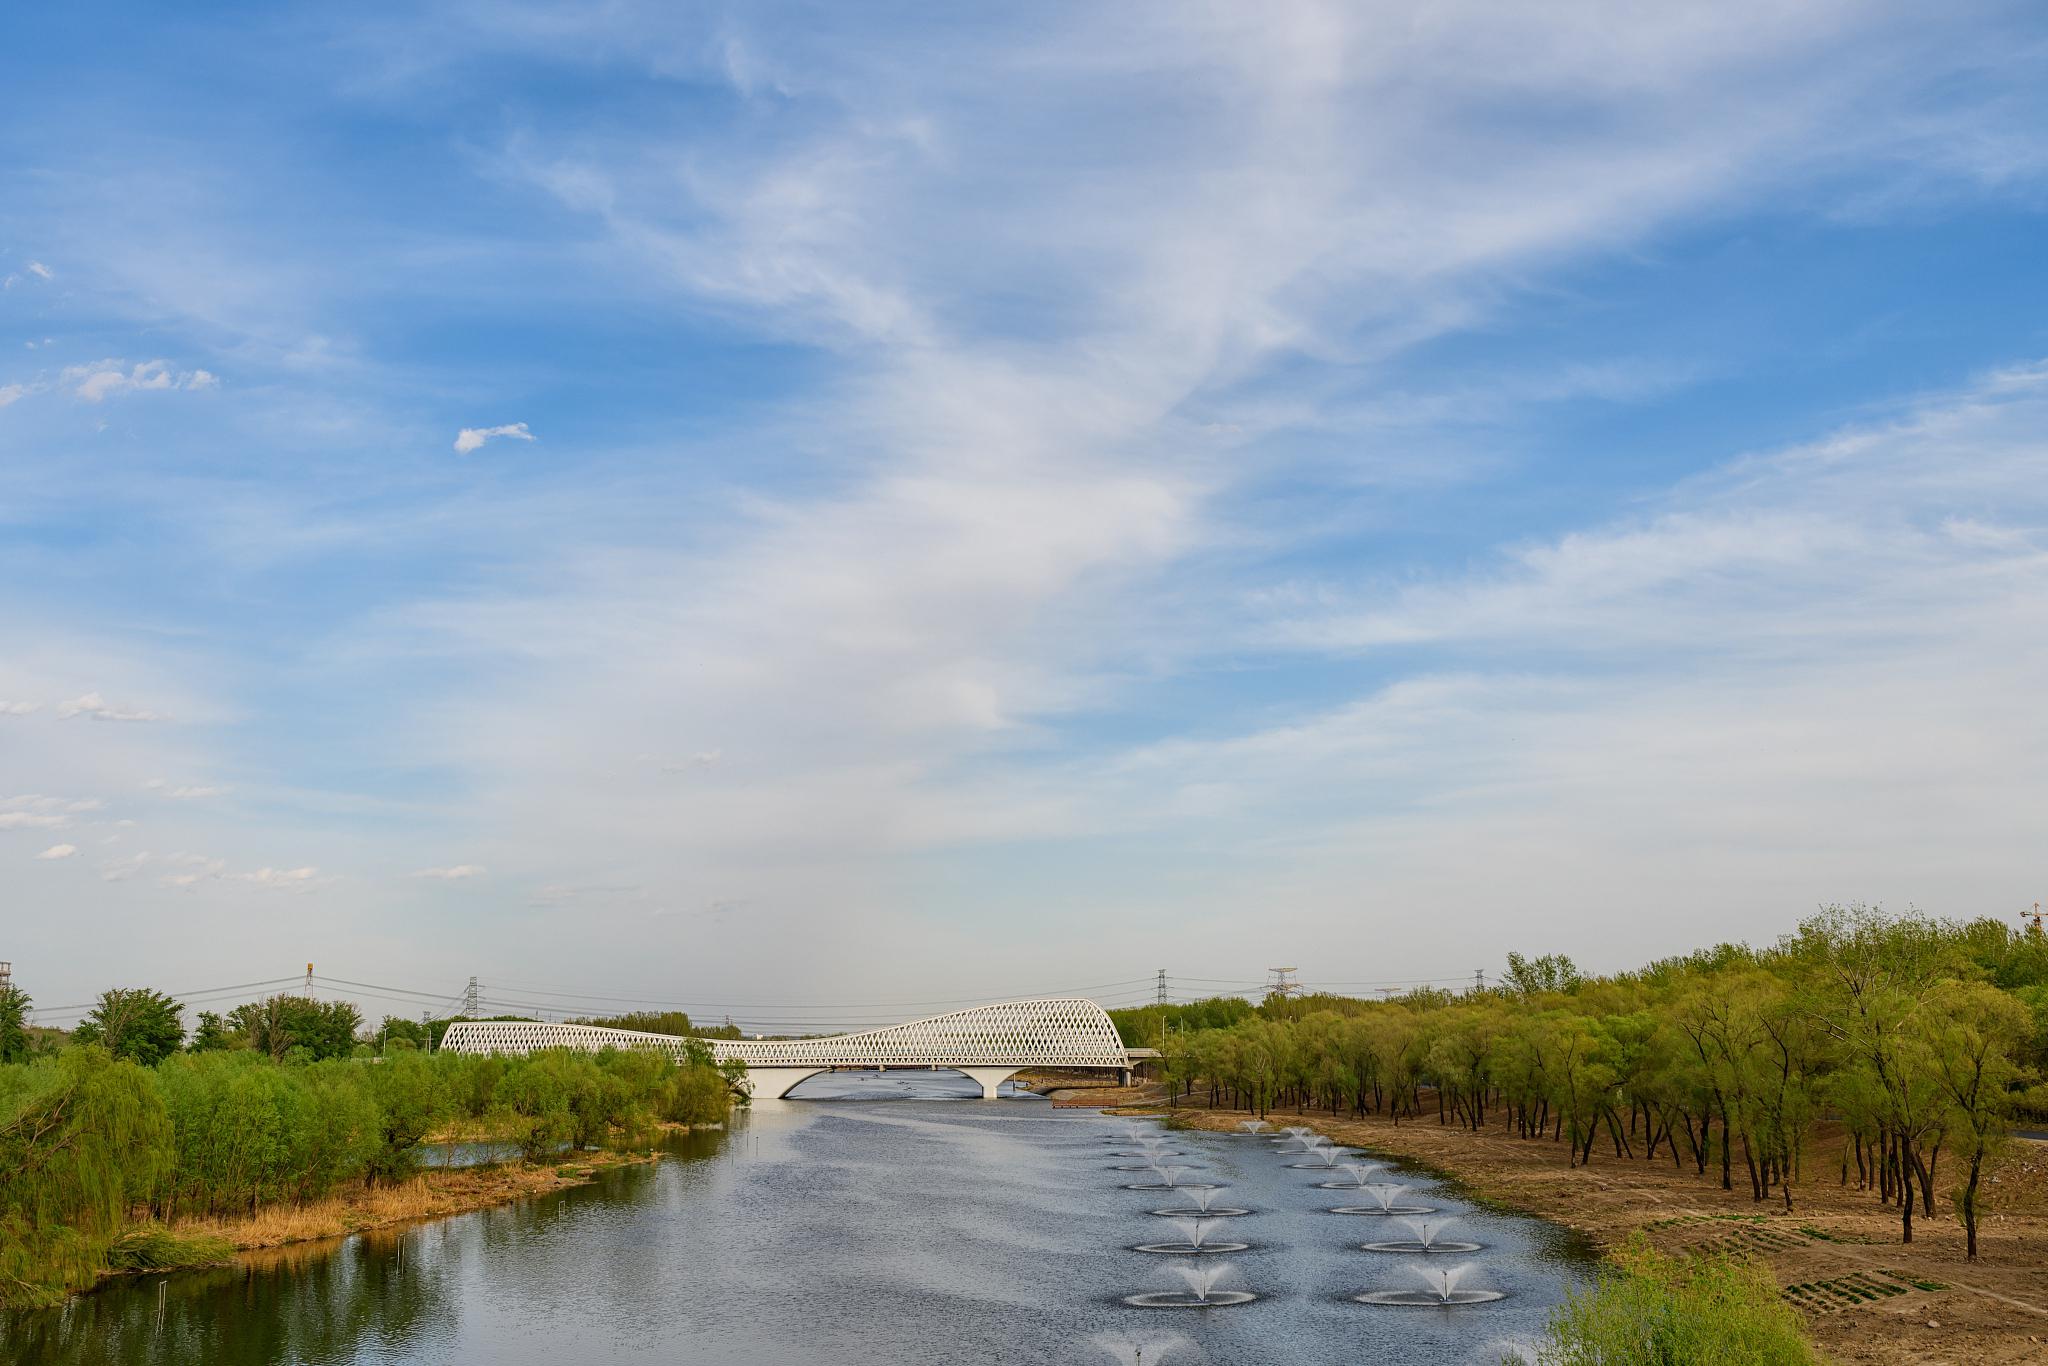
[440,995,1130,1100]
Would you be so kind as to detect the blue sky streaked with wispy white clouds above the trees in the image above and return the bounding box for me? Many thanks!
[0,2,2048,1014]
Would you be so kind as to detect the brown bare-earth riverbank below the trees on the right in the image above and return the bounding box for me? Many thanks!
[1124,1096,2048,1366]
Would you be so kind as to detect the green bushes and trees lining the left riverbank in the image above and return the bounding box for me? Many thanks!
[0,989,739,1307]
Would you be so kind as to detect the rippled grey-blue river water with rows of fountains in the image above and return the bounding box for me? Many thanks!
[0,1073,1585,1366]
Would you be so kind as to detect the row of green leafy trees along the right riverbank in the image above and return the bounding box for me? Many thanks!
[1112,907,2048,1257]
